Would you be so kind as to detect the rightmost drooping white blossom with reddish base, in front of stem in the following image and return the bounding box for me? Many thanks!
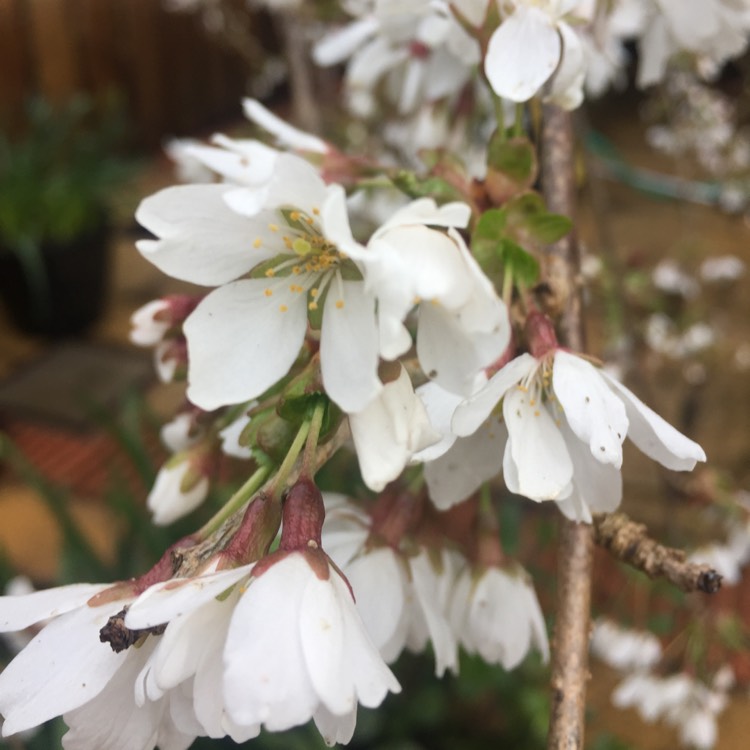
[426,313,706,521]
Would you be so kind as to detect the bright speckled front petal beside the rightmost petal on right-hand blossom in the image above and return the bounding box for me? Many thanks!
[552,350,628,469]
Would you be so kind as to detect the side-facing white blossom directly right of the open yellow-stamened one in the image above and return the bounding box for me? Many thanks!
[367,203,510,394]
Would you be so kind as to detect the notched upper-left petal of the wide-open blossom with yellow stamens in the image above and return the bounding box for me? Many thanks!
[135,185,275,286]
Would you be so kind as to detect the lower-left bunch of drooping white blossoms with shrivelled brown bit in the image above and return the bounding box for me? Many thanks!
[0,481,400,750]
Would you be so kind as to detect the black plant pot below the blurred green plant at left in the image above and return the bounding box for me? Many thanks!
[0,223,111,338]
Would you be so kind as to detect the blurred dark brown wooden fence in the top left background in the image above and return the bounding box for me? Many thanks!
[0,0,258,146]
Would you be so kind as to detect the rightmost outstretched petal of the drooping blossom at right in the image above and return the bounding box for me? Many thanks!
[602,372,706,471]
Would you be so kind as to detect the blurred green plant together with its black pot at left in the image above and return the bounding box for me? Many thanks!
[0,96,132,337]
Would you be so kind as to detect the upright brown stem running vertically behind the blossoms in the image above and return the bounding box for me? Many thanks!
[540,105,593,750]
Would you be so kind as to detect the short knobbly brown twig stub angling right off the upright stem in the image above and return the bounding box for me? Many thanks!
[593,513,721,594]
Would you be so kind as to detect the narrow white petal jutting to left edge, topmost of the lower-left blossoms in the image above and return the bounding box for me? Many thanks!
[0,583,110,633]
